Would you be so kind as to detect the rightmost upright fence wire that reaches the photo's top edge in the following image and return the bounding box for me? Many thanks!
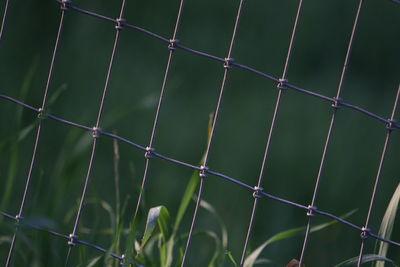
[299,0,364,266]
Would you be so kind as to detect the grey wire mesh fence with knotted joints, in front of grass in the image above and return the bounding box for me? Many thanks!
[0,0,400,266]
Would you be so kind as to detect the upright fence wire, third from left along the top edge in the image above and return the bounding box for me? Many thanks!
[65,0,126,266]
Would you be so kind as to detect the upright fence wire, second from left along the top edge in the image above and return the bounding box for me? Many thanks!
[0,5,66,267]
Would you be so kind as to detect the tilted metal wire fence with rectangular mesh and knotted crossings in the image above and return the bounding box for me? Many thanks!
[0,0,400,266]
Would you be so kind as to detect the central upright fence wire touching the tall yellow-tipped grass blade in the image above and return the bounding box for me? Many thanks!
[181,0,244,267]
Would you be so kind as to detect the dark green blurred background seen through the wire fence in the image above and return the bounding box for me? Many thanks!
[0,0,400,267]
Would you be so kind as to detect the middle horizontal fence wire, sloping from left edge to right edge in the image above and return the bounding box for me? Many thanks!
[0,94,400,248]
